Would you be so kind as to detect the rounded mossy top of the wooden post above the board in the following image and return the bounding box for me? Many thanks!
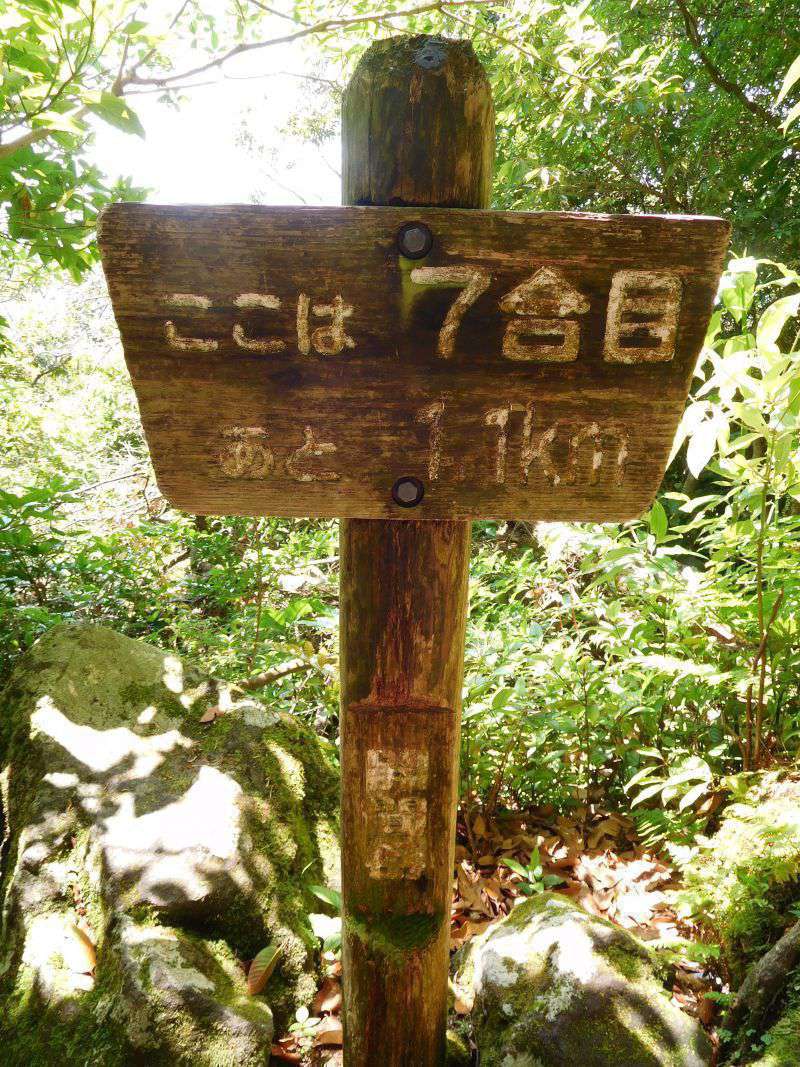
[342,34,494,207]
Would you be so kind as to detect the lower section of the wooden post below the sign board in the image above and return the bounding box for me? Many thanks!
[340,519,469,1067]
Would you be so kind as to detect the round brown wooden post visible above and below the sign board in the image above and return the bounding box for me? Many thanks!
[341,36,494,1067]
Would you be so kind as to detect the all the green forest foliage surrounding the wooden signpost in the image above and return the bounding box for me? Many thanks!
[0,0,800,1054]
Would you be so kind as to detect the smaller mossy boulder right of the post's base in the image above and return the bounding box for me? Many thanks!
[457,893,710,1067]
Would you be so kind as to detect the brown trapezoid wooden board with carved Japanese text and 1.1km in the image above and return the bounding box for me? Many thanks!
[99,204,729,521]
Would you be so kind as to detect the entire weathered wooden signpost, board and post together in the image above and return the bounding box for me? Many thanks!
[100,29,727,1067]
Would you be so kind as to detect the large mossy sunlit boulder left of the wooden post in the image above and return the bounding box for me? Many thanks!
[0,625,338,1067]
